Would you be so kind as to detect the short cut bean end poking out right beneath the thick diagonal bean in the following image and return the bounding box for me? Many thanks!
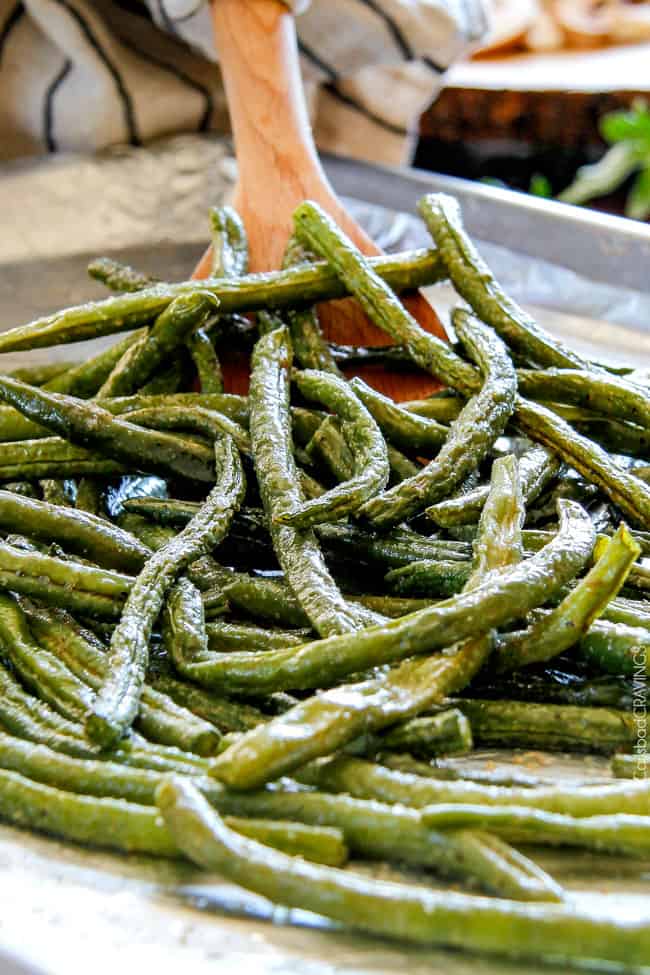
[373,708,474,757]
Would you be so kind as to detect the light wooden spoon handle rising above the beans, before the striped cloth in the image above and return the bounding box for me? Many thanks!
[202,0,378,271]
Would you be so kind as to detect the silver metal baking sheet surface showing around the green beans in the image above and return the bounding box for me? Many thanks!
[0,138,650,975]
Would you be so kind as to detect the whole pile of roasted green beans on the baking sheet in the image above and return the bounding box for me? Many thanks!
[0,195,650,971]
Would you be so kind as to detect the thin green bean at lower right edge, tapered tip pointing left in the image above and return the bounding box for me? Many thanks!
[422,804,650,857]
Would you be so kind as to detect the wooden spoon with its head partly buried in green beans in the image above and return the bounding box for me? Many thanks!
[194,0,445,400]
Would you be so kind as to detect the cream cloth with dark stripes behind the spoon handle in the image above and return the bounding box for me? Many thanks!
[0,0,487,163]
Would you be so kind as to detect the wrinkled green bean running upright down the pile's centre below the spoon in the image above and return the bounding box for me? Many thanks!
[249,328,358,636]
